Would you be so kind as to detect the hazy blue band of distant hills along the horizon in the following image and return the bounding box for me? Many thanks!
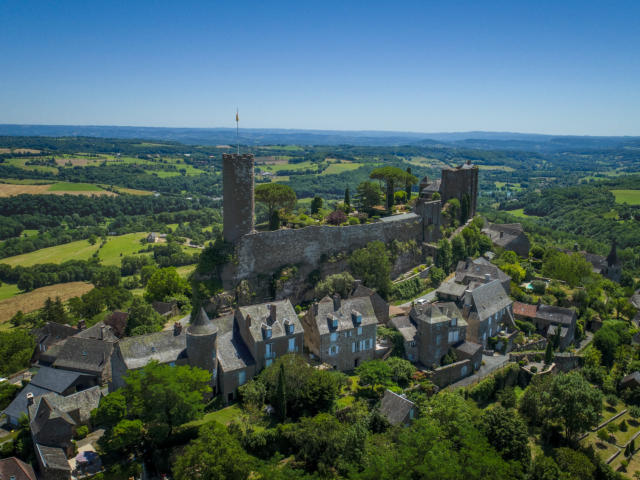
[0,124,640,152]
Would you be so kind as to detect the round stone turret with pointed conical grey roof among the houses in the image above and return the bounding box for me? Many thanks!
[187,307,218,390]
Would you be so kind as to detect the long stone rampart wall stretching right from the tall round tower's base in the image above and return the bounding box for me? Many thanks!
[225,214,422,283]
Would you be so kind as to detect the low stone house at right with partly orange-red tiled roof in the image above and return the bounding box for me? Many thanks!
[513,302,578,350]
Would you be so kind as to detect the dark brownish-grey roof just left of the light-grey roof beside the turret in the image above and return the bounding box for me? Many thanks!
[53,336,114,375]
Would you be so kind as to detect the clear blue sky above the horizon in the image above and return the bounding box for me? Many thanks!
[0,0,640,135]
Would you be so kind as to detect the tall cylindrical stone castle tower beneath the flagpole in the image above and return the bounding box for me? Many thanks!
[222,153,255,243]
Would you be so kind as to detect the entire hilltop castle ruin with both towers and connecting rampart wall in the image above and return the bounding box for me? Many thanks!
[221,154,478,304]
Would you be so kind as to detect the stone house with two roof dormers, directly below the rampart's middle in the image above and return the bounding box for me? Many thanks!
[303,295,378,371]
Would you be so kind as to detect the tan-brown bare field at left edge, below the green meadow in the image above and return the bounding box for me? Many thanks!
[0,282,93,329]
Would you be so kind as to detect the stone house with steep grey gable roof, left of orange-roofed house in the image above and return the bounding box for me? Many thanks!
[462,280,516,348]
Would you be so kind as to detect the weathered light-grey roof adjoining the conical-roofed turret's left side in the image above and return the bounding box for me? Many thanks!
[116,329,187,370]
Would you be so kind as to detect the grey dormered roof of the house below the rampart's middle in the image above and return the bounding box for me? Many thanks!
[315,297,378,335]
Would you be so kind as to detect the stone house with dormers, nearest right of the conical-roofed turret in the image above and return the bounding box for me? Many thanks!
[235,300,304,372]
